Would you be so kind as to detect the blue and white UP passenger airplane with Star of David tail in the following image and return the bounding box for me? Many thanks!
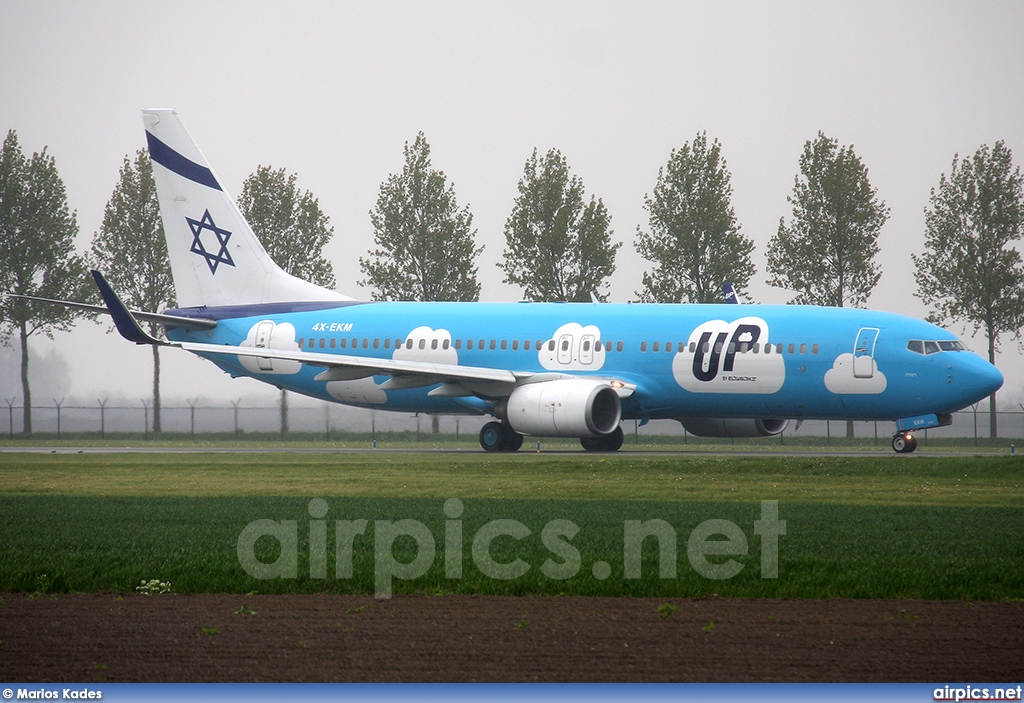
[24,108,1002,453]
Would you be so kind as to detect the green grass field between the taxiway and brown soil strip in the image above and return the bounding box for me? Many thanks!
[0,452,1024,600]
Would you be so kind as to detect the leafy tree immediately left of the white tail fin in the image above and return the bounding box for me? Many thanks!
[92,149,176,432]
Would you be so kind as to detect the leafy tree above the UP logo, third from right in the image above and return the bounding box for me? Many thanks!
[637,132,755,303]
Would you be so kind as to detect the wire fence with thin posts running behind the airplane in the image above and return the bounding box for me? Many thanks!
[0,399,1024,444]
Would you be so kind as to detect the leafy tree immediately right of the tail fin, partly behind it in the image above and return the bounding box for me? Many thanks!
[239,166,337,439]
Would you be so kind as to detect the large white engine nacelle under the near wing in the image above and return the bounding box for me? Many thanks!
[500,379,623,437]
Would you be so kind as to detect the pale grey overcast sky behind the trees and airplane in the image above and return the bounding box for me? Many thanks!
[0,0,1024,415]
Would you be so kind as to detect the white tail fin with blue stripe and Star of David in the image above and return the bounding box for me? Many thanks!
[142,109,351,307]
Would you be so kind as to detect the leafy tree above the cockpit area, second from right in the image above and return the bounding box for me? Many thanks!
[768,132,889,307]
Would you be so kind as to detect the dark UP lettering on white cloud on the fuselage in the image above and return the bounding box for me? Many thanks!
[672,317,785,394]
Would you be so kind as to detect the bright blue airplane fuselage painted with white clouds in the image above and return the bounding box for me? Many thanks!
[168,302,1002,420]
